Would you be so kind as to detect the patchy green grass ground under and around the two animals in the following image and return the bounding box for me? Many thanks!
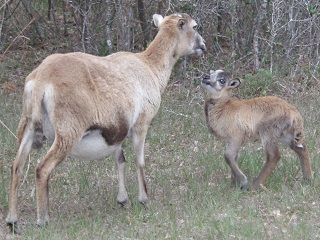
[0,59,320,240]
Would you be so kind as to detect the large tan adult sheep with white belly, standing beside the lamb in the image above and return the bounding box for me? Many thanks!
[6,14,206,226]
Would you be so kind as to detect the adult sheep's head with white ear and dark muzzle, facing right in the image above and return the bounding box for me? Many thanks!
[153,13,206,57]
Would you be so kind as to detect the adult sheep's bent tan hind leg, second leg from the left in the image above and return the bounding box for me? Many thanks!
[36,135,72,226]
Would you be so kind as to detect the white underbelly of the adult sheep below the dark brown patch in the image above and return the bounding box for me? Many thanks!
[70,131,121,160]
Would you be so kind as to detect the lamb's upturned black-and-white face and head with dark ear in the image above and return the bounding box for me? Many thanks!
[201,70,241,98]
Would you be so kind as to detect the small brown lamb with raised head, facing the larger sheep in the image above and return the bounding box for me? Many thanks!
[201,70,312,189]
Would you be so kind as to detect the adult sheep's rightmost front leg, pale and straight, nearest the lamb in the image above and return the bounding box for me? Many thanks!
[133,128,148,203]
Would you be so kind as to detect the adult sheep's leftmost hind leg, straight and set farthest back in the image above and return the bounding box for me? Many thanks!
[6,122,34,227]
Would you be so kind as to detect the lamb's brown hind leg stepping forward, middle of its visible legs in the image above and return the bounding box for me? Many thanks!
[252,142,280,189]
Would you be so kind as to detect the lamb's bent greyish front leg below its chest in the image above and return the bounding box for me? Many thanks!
[224,140,248,189]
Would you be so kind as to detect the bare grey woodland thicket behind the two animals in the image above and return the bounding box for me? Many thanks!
[0,0,320,82]
